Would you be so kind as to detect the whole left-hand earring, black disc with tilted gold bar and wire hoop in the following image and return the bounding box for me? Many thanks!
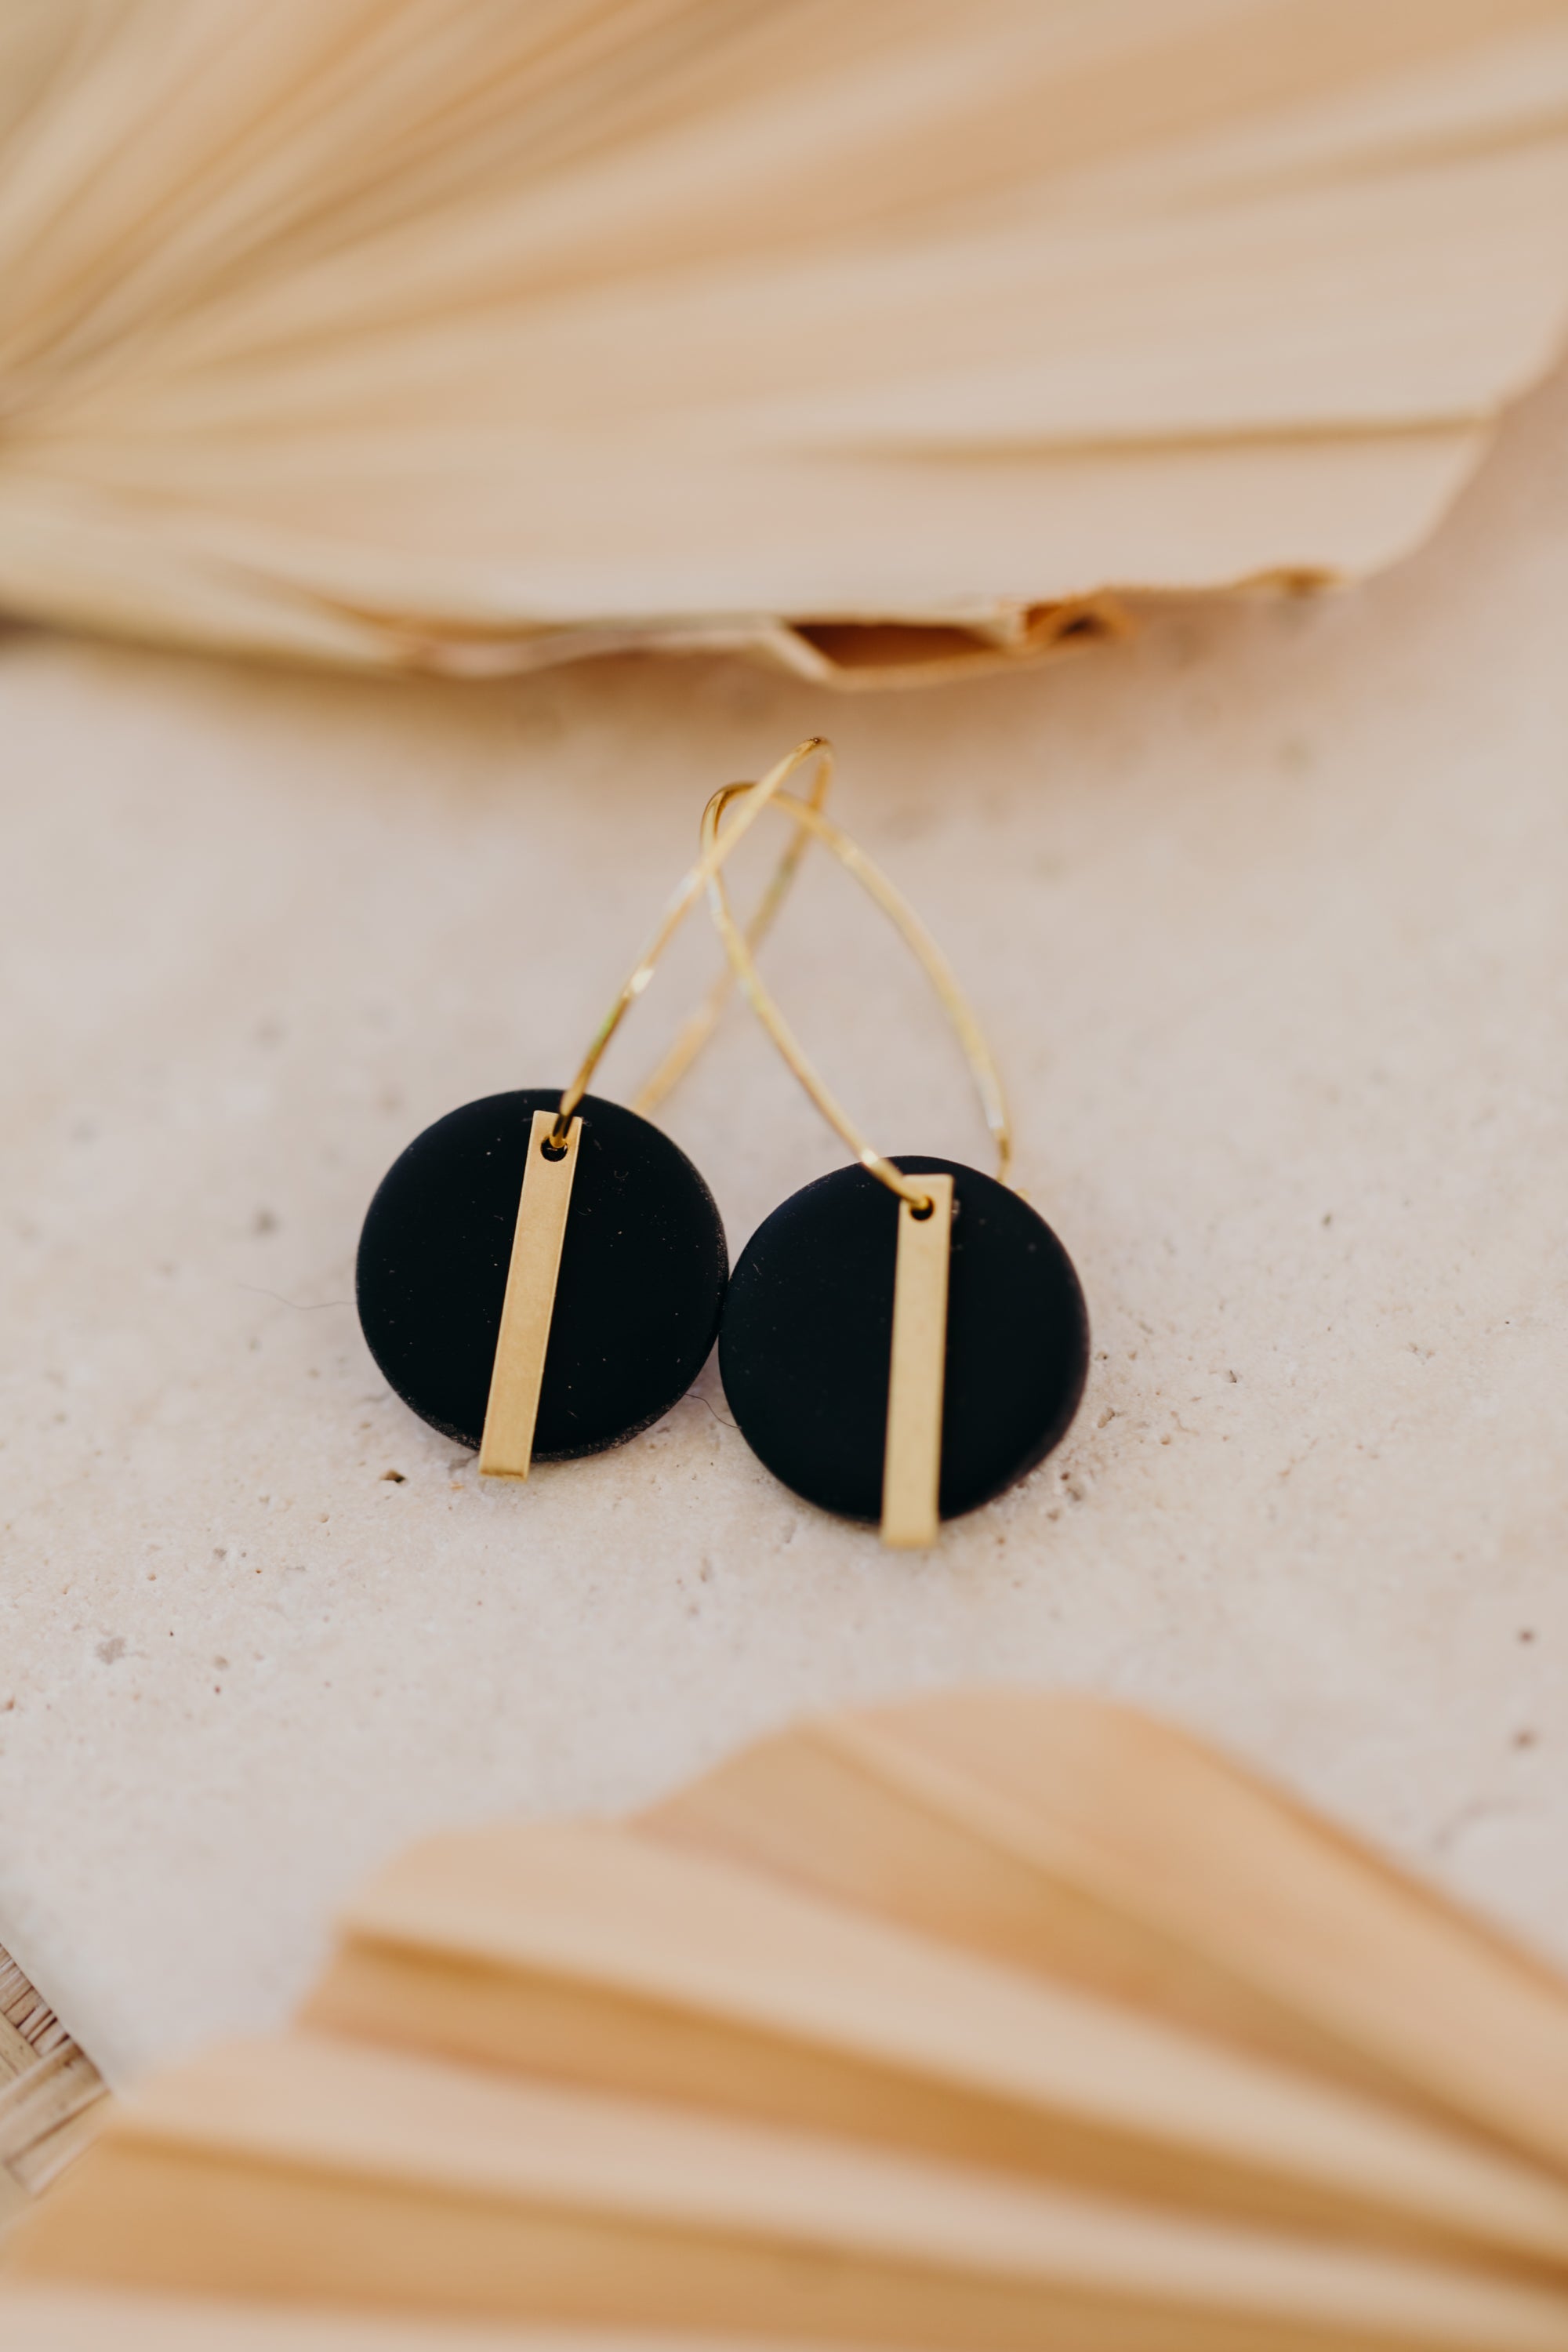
[355,739,829,1477]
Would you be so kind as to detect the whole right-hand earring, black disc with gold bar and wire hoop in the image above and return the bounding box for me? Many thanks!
[703,786,1088,1548]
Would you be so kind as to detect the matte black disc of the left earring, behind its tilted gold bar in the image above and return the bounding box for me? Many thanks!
[355,1087,729,1463]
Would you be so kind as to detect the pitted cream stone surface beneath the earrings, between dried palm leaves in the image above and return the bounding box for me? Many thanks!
[0,372,1568,2074]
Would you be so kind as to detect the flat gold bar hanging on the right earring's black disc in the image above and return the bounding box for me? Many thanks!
[881,1176,952,1552]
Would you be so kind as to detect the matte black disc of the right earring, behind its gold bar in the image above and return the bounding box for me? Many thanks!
[720,1157,1088,1519]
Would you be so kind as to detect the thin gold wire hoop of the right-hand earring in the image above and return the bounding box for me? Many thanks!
[703,771,1013,1214]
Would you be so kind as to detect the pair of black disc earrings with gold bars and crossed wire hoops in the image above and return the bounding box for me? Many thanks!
[358,736,1088,1548]
